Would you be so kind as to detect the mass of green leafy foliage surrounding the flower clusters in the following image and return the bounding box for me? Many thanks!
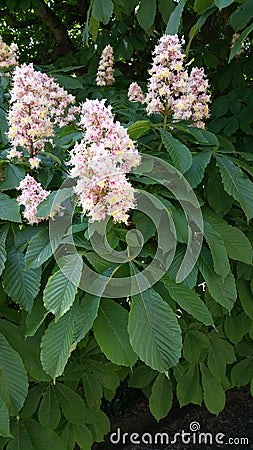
[0,0,253,450]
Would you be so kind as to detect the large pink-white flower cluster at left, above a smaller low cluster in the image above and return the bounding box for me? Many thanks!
[8,64,77,153]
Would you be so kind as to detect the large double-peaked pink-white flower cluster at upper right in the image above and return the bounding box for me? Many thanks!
[143,35,210,128]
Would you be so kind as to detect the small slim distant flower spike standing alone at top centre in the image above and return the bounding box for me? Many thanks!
[96,45,115,86]
